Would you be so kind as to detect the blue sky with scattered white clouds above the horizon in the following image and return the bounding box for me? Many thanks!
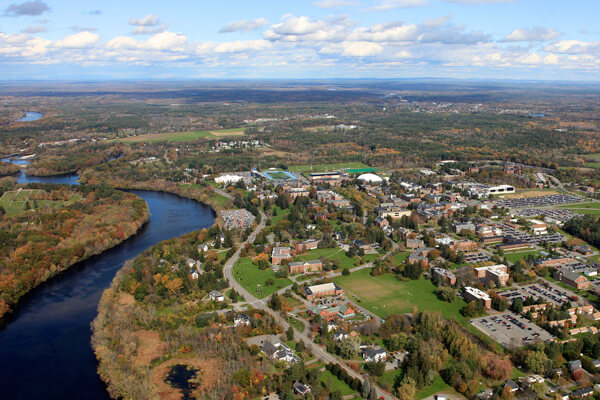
[0,0,600,81]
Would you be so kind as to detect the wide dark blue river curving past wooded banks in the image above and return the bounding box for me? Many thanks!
[0,172,214,400]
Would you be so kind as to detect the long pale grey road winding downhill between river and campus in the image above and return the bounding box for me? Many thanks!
[223,210,395,400]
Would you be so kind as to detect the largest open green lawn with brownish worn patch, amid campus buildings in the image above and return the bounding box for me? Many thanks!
[335,269,468,326]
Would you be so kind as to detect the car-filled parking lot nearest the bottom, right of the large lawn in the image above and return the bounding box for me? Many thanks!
[470,311,553,348]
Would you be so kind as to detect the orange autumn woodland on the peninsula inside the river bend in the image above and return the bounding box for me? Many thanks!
[0,184,148,318]
